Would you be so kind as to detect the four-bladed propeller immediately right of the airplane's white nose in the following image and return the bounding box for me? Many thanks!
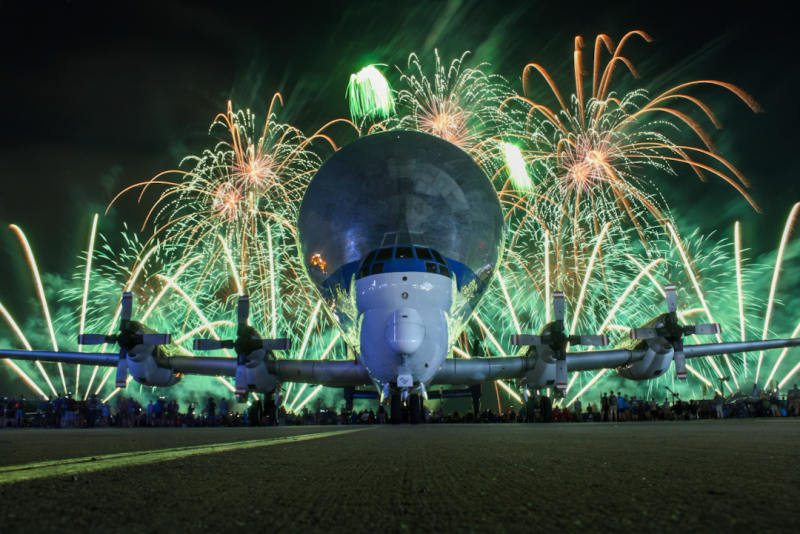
[511,291,609,391]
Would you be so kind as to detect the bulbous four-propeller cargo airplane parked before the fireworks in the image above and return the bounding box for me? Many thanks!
[0,131,800,424]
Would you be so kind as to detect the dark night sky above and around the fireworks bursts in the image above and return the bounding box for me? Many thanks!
[0,0,800,354]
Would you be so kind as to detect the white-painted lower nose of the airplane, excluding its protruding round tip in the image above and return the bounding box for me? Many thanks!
[356,272,453,388]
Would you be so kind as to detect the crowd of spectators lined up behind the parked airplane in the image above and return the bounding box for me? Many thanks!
[0,384,800,428]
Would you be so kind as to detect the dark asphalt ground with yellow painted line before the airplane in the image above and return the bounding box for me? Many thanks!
[0,420,800,534]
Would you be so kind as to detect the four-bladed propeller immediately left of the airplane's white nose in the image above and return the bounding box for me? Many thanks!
[194,295,292,402]
